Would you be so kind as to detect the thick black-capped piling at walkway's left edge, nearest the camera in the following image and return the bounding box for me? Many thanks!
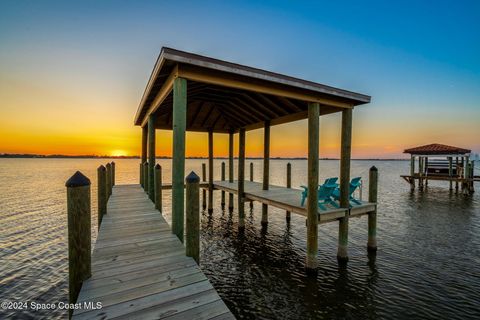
[65,171,92,316]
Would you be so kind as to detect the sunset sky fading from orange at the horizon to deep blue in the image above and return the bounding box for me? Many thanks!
[0,0,480,158]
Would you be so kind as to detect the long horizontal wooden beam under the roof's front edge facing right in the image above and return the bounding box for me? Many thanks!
[178,64,352,108]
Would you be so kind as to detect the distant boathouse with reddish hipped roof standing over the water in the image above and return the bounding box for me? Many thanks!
[401,143,474,193]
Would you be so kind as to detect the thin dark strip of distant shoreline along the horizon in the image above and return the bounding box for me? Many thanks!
[0,153,410,161]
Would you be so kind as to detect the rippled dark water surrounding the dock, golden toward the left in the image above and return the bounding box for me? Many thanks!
[0,159,480,319]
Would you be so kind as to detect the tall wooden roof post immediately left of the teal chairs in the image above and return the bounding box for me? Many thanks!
[305,103,320,273]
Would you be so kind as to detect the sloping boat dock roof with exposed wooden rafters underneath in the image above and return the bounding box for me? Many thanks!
[134,47,370,133]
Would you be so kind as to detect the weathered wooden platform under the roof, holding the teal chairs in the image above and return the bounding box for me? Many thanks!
[213,181,376,223]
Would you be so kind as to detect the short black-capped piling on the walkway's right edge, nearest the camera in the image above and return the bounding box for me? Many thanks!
[185,171,200,264]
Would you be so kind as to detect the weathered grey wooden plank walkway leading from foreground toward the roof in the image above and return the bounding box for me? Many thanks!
[73,185,235,319]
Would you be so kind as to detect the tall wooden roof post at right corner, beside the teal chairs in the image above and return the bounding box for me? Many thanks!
[338,109,353,261]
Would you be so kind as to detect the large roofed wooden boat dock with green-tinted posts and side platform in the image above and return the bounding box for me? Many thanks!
[134,48,376,270]
